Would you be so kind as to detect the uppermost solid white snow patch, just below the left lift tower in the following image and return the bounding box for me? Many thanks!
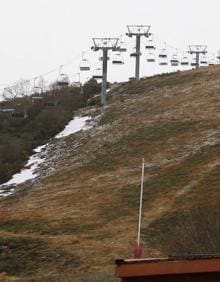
[55,116,91,139]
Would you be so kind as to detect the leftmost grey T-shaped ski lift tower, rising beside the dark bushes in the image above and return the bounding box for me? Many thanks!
[92,37,120,106]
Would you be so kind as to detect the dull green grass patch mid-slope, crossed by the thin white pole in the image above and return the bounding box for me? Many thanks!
[100,165,190,221]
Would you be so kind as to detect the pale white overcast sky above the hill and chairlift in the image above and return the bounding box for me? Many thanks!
[0,0,220,90]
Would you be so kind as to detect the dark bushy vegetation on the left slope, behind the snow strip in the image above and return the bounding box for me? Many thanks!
[0,80,100,184]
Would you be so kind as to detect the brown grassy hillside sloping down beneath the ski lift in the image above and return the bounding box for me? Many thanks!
[0,66,220,281]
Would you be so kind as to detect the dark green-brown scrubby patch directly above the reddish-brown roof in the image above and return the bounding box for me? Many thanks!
[142,205,220,255]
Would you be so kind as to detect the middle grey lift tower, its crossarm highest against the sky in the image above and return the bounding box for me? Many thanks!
[126,25,151,80]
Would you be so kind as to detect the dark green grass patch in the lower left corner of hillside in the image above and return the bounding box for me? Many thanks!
[0,237,80,276]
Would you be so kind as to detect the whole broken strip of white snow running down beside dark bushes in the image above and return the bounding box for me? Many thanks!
[0,116,91,198]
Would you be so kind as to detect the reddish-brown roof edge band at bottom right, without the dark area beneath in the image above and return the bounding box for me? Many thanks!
[116,256,220,278]
